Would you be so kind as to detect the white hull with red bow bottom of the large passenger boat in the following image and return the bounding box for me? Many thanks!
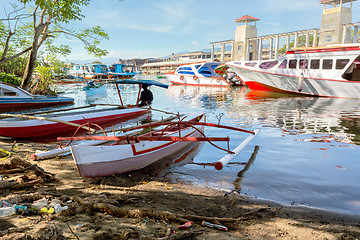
[228,64,360,98]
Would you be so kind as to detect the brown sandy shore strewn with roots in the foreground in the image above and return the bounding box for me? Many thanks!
[0,139,360,240]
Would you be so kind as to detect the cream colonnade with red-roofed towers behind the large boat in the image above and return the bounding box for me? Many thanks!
[210,0,360,62]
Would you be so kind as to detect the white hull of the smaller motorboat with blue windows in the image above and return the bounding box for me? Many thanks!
[165,74,230,87]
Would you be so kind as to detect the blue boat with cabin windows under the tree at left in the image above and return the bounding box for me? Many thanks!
[0,82,74,109]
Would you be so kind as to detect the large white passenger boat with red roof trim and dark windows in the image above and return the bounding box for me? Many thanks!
[226,44,360,98]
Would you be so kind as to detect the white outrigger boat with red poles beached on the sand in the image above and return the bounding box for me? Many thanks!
[58,115,258,177]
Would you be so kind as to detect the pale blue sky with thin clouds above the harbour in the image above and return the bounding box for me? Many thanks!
[0,0,360,63]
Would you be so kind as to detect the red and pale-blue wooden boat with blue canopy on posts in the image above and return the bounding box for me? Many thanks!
[0,80,168,138]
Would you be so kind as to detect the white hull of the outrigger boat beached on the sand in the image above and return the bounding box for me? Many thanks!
[70,127,203,178]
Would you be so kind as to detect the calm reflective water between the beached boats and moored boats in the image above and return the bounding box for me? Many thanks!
[58,79,360,214]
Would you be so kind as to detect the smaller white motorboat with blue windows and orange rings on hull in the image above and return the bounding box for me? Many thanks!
[164,62,231,87]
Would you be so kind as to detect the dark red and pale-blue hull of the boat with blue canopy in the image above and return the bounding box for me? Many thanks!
[0,108,150,138]
